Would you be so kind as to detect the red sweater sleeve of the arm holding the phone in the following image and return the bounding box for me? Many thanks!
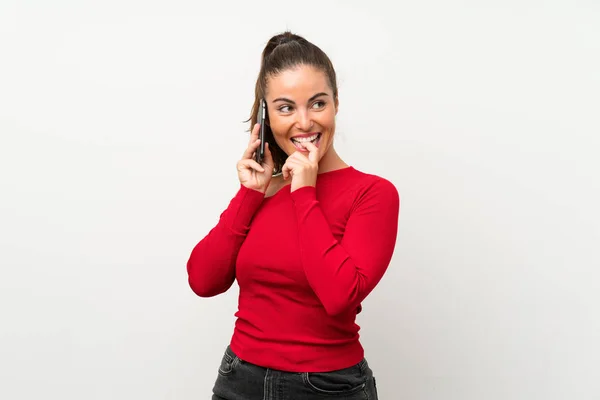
[187,185,264,297]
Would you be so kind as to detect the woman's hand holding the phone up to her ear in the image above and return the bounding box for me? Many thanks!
[237,124,274,193]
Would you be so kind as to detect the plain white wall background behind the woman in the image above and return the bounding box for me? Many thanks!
[0,0,600,400]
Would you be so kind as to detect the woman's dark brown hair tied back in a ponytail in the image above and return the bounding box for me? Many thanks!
[246,31,338,173]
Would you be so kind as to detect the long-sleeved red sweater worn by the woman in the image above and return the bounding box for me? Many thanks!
[187,167,400,372]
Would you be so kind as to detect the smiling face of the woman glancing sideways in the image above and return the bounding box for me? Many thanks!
[265,65,338,158]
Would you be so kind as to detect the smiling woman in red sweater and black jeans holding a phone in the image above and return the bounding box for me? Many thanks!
[187,32,400,400]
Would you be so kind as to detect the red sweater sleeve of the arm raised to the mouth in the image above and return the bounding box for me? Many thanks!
[292,179,400,315]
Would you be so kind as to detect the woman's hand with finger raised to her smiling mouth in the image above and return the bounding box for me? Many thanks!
[281,142,319,192]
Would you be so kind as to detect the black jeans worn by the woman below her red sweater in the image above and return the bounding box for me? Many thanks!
[212,346,377,400]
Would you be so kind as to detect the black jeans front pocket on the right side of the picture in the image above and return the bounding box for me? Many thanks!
[302,362,367,396]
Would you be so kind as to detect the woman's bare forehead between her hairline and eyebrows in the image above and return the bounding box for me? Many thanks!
[266,65,331,100]
